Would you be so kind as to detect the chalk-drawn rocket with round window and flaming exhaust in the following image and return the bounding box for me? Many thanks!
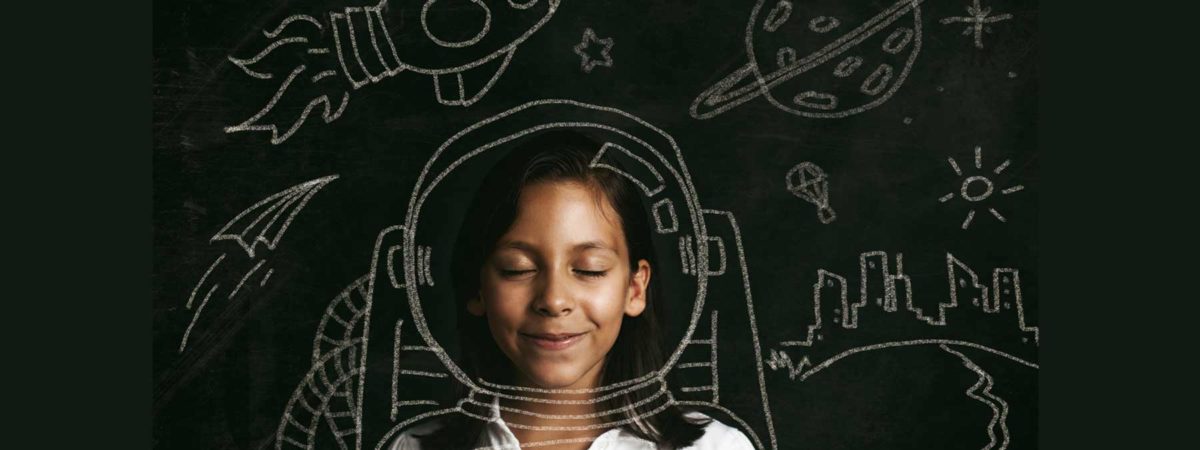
[224,0,561,145]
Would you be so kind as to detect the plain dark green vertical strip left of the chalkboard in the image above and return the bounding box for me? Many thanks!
[13,1,152,449]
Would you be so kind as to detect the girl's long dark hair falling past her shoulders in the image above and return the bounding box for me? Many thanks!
[418,128,707,449]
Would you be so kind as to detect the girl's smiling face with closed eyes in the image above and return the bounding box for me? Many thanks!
[467,181,650,389]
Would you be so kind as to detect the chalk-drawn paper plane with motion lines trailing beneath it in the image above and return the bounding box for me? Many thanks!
[179,174,337,353]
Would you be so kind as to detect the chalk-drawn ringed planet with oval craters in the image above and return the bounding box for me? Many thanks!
[689,0,924,120]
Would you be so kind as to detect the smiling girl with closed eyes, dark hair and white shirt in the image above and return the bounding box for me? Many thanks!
[391,130,752,450]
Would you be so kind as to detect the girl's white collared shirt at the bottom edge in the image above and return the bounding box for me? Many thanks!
[389,403,754,450]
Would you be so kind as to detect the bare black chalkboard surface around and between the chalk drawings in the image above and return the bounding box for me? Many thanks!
[152,1,1039,449]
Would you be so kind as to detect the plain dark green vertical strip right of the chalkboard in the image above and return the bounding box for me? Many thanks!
[1039,1,1180,449]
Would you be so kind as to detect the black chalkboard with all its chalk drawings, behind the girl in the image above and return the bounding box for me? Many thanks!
[152,0,1040,449]
